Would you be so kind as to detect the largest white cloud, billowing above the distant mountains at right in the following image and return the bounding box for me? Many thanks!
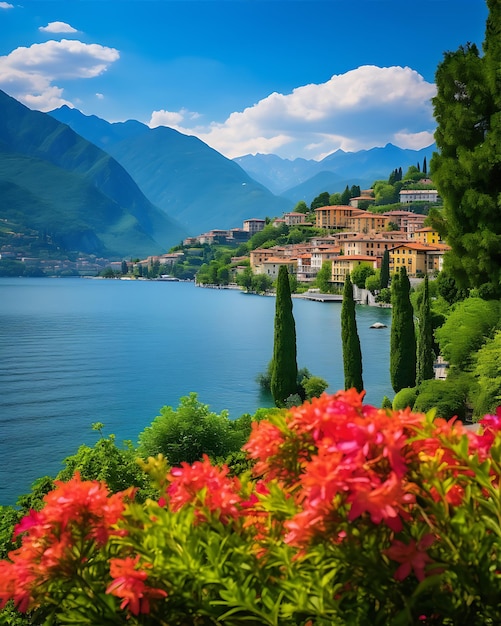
[150,66,435,159]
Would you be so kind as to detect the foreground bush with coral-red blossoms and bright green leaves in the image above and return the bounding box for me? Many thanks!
[0,390,501,626]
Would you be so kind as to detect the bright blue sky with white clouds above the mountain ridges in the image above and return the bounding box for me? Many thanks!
[0,0,487,159]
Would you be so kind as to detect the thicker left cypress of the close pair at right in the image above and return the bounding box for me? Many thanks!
[390,266,416,393]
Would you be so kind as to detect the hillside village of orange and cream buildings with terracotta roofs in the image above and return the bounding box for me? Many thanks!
[123,184,449,288]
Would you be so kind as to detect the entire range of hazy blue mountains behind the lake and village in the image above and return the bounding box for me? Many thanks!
[0,85,434,258]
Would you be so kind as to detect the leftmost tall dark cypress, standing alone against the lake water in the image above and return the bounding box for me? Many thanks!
[270,265,298,406]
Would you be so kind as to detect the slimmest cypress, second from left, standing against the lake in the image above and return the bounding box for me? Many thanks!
[341,274,364,391]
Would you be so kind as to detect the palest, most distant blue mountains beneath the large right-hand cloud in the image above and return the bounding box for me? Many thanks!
[234,144,436,204]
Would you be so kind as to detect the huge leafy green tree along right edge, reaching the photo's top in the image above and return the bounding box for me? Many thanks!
[430,0,501,297]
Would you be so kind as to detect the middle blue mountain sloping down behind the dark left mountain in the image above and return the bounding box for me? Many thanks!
[50,106,293,235]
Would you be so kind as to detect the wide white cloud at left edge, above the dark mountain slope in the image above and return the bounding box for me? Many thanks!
[0,39,120,111]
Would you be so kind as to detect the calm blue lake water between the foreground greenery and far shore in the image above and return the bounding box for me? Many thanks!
[0,278,392,504]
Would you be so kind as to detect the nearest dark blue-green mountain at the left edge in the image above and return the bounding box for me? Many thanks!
[0,91,186,257]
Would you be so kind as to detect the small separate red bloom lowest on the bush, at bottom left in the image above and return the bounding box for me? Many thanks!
[106,555,167,615]
